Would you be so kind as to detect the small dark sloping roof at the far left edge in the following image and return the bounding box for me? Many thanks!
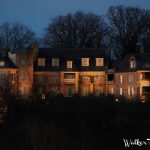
[0,56,17,69]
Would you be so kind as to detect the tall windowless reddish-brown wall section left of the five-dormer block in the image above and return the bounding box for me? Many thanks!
[16,49,33,99]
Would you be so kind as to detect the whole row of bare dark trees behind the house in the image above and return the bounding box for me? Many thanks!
[0,6,150,59]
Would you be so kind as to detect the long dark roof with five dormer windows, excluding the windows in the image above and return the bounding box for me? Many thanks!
[34,48,107,71]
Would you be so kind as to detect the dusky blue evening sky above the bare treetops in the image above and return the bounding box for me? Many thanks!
[0,0,150,35]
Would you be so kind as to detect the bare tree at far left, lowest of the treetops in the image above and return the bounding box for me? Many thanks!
[0,22,35,53]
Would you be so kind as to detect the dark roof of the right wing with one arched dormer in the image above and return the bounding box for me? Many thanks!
[116,53,150,72]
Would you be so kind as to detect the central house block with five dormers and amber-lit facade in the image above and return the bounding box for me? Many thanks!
[34,48,106,96]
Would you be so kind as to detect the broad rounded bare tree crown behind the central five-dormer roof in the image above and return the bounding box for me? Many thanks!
[43,11,107,48]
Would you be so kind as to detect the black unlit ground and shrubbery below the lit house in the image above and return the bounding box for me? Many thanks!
[0,97,150,150]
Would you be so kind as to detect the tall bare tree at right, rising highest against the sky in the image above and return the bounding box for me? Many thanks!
[107,6,150,57]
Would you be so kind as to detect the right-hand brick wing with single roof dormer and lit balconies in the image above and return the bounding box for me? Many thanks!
[115,53,150,100]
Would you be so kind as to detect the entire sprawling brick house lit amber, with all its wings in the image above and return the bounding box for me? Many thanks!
[0,46,150,99]
